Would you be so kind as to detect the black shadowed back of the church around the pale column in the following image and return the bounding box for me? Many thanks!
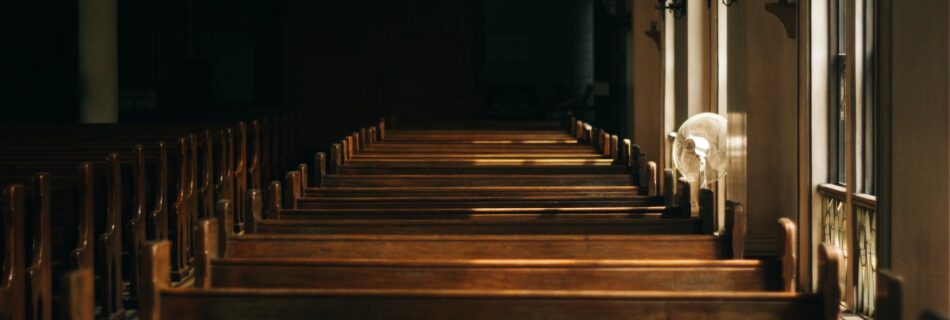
[0,0,630,154]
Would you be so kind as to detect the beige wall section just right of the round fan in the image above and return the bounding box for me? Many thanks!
[727,0,798,254]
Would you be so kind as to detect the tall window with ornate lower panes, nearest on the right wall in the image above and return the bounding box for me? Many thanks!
[818,0,877,316]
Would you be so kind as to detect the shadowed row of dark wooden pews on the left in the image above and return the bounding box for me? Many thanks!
[0,116,295,319]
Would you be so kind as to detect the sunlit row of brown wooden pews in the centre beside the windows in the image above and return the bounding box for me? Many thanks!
[130,117,840,319]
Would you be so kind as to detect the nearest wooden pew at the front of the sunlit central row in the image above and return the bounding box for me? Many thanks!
[122,238,841,320]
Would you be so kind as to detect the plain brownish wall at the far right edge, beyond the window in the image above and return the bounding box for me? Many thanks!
[885,0,950,319]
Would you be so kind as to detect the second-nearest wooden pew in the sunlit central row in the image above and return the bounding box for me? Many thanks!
[198,214,772,291]
